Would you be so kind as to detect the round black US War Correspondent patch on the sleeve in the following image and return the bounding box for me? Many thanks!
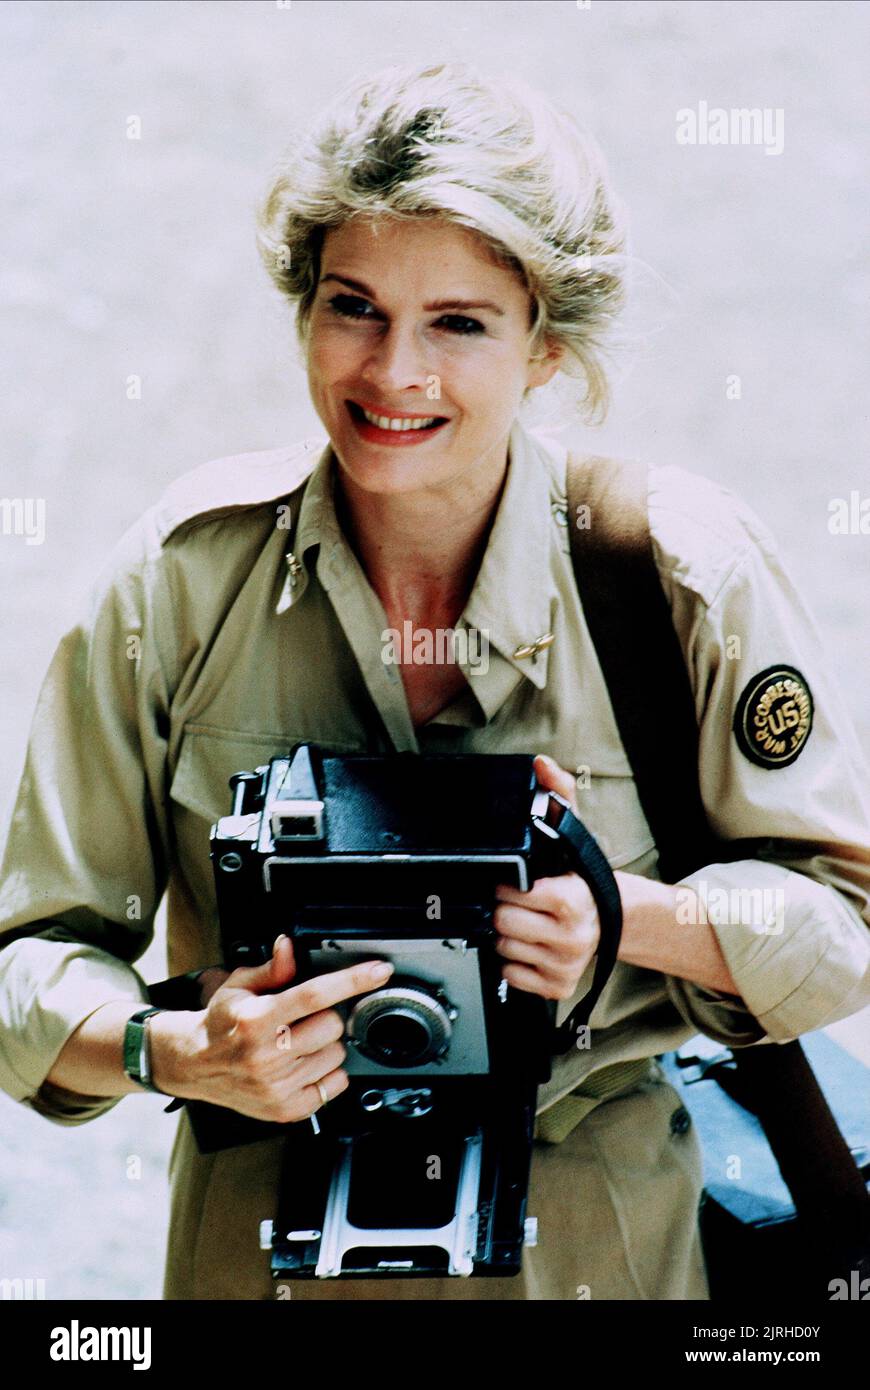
[734,666,813,767]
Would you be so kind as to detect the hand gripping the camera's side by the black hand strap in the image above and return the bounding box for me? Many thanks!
[493,755,600,999]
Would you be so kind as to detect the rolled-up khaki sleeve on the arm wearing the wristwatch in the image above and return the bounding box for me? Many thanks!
[0,517,168,1125]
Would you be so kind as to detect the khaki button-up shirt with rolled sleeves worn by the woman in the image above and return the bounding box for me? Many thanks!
[0,421,870,1295]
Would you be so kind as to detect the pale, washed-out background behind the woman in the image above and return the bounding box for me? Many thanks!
[0,0,870,1298]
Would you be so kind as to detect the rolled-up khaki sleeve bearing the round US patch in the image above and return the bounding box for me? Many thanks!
[667,518,870,1045]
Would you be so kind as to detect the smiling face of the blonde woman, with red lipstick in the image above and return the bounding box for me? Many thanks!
[307,218,560,493]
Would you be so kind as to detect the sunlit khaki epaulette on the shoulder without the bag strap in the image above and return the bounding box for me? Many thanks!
[154,435,328,545]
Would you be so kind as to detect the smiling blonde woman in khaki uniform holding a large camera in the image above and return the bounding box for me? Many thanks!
[0,65,870,1300]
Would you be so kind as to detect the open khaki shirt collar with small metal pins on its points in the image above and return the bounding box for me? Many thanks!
[277,420,560,706]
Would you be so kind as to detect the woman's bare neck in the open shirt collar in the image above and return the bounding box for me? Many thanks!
[335,442,507,626]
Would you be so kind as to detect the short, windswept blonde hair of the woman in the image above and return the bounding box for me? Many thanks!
[257,63,627,420]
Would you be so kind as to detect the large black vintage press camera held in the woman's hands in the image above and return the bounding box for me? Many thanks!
[188,744,618,1279]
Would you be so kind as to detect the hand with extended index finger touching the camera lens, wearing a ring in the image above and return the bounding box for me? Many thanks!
[150,937,393,1125]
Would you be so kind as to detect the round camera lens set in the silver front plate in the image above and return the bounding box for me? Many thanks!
[347,979,453,1068]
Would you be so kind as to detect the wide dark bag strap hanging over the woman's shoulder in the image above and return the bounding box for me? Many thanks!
[566,455,870,1277]
